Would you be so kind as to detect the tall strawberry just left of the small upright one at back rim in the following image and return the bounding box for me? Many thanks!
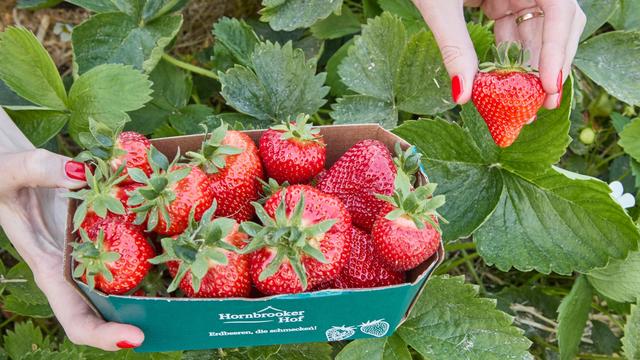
[187,123,264,221]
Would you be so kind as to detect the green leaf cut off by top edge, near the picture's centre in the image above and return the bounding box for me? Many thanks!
[260,0,342,31]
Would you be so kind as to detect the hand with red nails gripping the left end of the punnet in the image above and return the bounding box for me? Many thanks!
[0,108,144,351]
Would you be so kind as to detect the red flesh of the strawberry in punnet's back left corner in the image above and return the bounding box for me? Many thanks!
[109,131,152,185]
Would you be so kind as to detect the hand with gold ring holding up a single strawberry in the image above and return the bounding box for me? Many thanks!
[414,0,587,109]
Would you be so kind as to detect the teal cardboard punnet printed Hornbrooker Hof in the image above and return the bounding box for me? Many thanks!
[64,125,444,352]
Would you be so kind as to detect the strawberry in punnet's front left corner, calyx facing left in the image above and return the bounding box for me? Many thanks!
[72,219,155,294]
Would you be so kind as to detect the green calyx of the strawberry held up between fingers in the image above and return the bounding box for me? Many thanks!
[480,41,533,73]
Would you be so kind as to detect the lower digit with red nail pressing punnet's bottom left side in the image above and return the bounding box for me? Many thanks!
[36,264,144,351]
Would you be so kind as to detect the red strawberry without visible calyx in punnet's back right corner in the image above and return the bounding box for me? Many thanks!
[318,140,396,231]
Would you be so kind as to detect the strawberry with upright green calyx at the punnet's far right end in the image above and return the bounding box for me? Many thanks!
[371,171,444,271]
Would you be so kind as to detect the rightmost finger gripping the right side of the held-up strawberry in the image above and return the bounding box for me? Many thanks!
[538,0,578,95]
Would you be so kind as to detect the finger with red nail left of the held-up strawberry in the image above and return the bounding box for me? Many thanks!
[415,0,478,104]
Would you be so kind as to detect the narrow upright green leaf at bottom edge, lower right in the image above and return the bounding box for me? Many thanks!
[558,276,593,360]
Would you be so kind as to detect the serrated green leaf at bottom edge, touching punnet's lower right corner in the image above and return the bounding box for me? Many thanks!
[397,276,533,360]
